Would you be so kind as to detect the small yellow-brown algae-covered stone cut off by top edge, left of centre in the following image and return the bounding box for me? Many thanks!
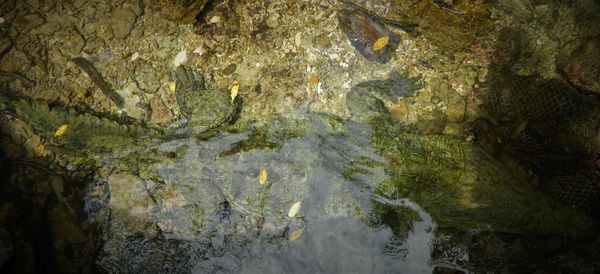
[159,0,210,24]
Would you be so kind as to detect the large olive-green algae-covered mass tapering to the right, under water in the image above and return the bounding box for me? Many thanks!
[371,114,593,235]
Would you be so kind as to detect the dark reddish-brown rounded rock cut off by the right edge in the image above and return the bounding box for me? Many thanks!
[562,37,600,94]
